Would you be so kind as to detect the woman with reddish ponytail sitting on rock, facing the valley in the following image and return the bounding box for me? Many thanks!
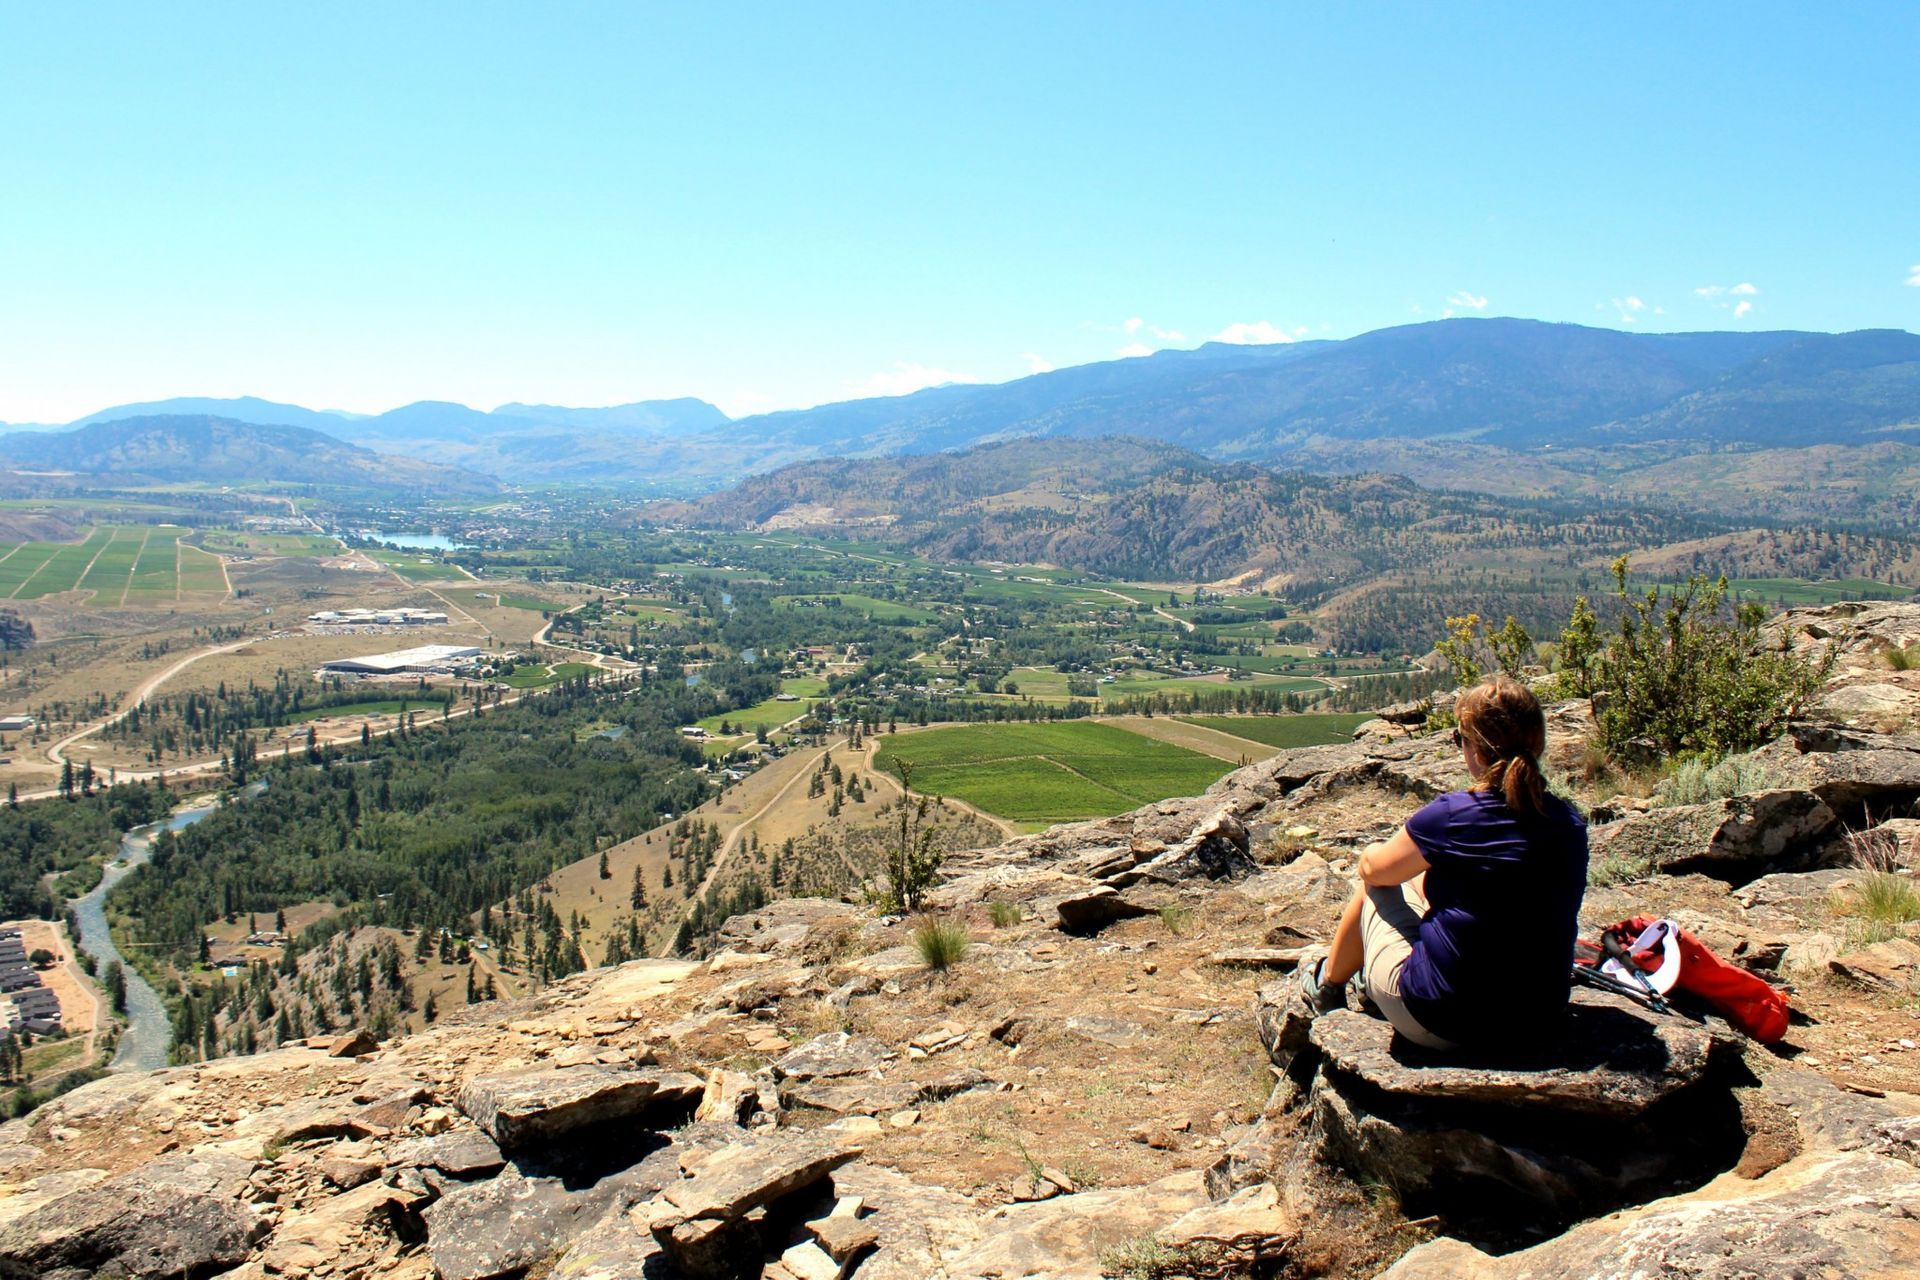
[1300,676,1586,1050]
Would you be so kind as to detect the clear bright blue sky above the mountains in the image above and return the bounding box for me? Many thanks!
[0,4,1920,422]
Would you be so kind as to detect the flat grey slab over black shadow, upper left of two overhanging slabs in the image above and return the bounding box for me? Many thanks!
[461,1063,705,1151]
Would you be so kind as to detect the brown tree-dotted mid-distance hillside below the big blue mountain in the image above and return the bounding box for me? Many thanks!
[652,439,1916,597]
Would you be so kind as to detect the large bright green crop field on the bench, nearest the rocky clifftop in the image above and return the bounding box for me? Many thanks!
[874,722,1233,827]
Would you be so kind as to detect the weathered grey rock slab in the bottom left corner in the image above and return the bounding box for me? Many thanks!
[0,1153,267,1280]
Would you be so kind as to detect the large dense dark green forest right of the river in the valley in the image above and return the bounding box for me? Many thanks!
[109,679,756,960]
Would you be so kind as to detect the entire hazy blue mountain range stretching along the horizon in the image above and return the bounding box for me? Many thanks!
[15,319,1920,493]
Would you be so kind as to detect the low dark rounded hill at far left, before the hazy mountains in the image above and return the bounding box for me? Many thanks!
[0,415,499,493]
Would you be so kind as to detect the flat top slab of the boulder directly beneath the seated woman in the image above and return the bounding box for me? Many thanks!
[1311,990,1713,1115]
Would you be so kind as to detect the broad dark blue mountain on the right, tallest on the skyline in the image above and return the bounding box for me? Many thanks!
[710,319,1920,461]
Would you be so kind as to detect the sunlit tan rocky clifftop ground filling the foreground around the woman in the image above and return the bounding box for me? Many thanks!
[0,606,1920,1280]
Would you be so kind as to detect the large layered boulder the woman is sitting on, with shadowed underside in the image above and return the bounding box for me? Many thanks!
[1260,984,1743,1230]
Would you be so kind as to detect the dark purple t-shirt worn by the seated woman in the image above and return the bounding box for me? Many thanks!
[1400,791,1586,1044]
